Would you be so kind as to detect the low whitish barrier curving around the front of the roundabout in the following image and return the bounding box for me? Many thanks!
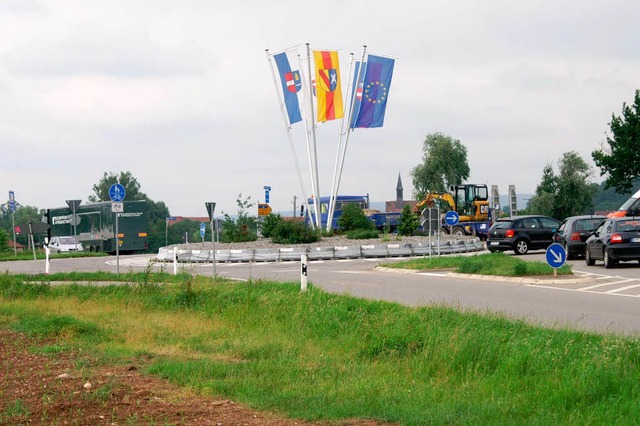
[156,238,484,263]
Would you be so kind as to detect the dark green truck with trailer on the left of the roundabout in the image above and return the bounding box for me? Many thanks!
[43,201,149,254]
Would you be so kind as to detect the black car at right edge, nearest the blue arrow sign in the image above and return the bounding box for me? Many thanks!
[584,216,640,268]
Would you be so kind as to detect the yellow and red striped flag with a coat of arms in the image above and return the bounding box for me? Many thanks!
[313,50,344,122]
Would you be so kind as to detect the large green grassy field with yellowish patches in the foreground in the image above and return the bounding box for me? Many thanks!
[0,271,640,425]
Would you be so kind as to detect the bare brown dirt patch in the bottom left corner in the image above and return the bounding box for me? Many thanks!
[0,330,390,426]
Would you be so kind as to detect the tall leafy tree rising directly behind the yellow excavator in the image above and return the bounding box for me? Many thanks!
[411,133,470,199]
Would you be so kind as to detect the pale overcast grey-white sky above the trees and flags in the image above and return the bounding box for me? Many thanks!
[0,0,640,216]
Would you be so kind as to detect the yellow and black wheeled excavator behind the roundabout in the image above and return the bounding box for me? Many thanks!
[416,184,491,240]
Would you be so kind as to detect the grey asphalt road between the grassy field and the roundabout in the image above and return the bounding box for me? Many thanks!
[5,251,640,337]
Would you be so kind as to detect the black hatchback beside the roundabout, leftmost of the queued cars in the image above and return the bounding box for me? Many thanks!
[487,215,560,254]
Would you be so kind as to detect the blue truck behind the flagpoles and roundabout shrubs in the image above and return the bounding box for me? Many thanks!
[302,194,402,230]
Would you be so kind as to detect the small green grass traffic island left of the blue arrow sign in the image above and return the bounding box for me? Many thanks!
[382,253,573,277]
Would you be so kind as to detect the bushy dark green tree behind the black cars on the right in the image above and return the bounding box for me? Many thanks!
[522,151,596,220]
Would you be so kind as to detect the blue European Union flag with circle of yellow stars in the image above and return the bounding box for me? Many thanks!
[351,55,395,128]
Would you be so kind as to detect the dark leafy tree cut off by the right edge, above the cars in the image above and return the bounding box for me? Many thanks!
[591,90,640,192]
